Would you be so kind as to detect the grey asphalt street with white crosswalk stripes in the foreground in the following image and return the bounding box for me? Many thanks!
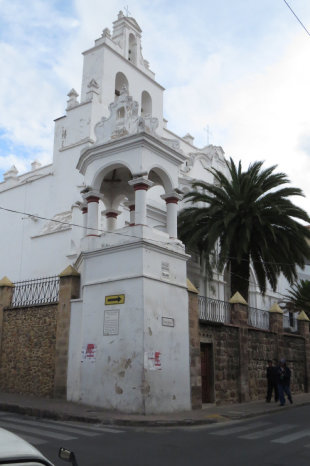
[0,406,310,466]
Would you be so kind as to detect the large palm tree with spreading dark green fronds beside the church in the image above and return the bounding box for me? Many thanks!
[179,159,310,300]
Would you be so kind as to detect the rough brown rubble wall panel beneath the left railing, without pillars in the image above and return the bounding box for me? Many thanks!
[0,305,57,397]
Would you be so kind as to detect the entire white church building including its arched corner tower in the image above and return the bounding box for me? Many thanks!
[0,12,306,413]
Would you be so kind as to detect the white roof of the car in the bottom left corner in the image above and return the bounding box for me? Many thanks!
[0,427,53,466]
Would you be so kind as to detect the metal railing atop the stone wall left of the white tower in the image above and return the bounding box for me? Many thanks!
[12,275,59,307]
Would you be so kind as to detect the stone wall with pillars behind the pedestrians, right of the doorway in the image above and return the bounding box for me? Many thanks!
[200,305,310,404]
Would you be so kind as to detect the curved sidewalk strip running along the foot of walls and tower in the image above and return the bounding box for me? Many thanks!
[0,392,310,427]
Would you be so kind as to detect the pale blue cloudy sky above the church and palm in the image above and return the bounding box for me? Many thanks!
[0,0,310,213]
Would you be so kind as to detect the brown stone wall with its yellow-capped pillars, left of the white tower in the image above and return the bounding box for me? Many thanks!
[0,266,80,398]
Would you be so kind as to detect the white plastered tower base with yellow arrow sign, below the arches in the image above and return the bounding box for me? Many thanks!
[68,226,191,414]
